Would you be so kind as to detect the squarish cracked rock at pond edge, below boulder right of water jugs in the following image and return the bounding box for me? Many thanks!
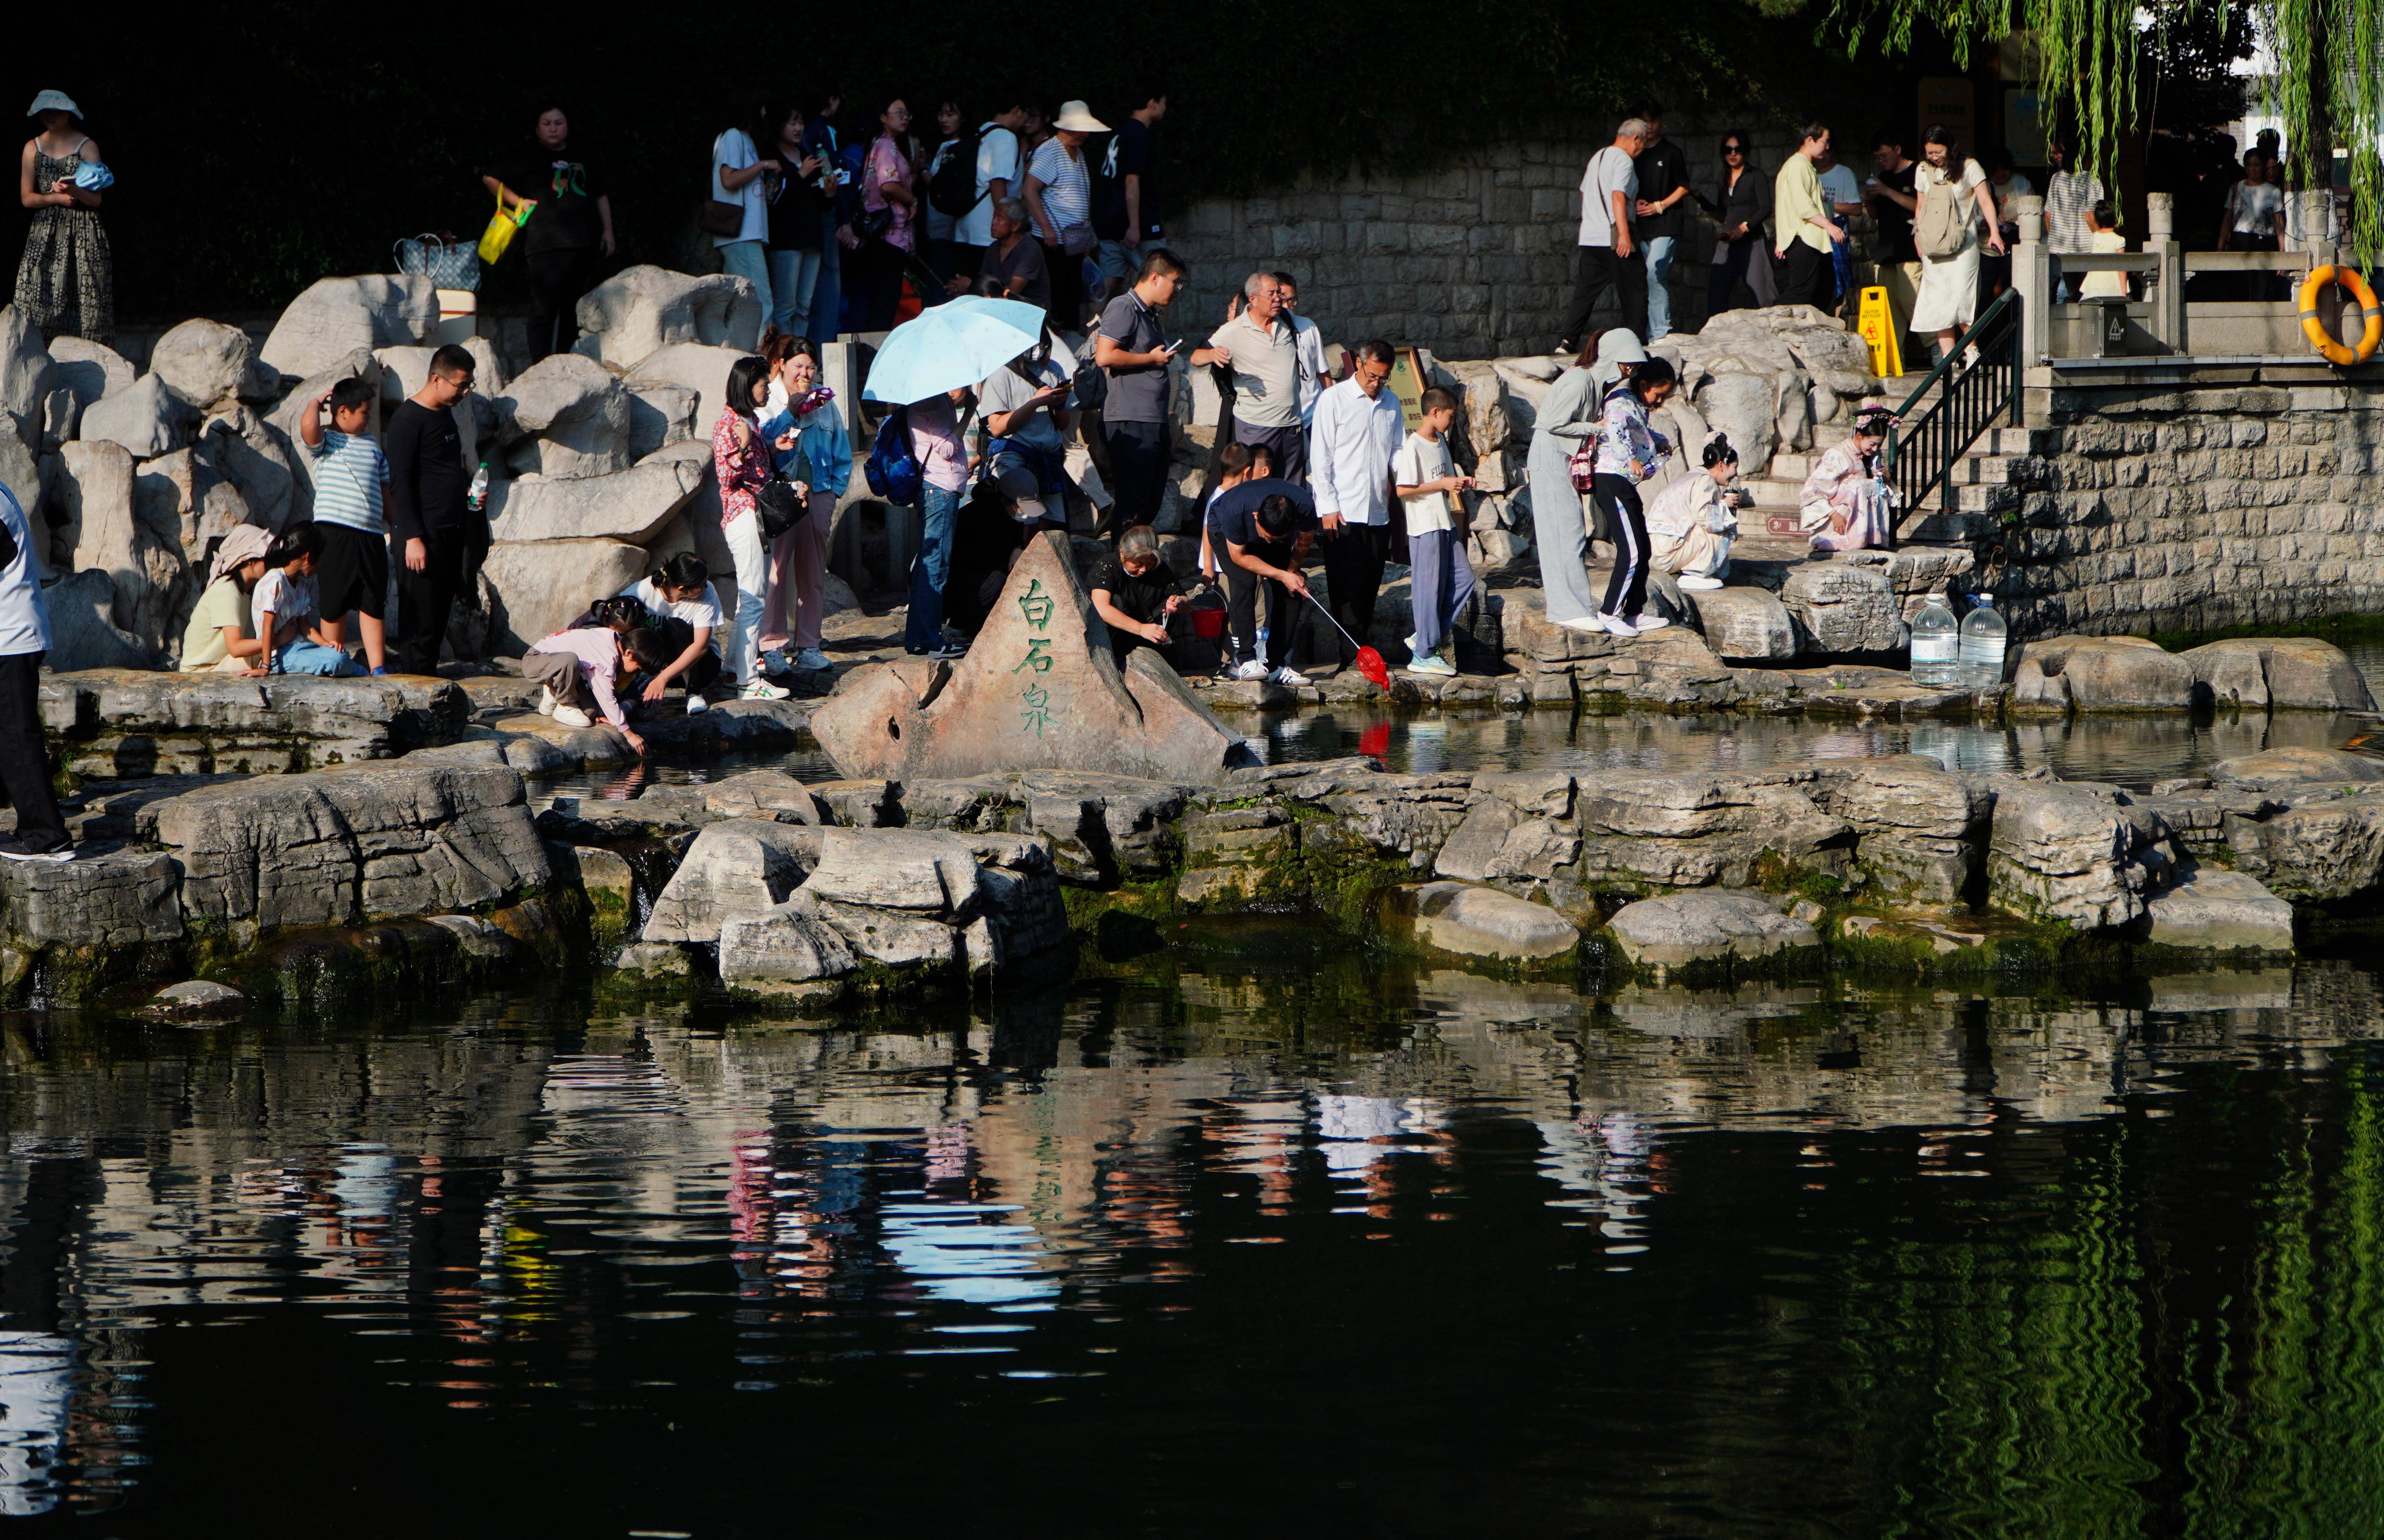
[1986,777,2165,930]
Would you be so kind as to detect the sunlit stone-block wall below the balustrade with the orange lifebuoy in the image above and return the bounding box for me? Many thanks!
[2003,381,2384,637]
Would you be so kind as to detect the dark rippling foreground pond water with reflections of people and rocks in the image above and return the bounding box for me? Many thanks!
[0,949,2384,1538]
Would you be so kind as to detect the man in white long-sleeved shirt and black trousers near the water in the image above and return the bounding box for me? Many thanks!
[1309,341,1407,663]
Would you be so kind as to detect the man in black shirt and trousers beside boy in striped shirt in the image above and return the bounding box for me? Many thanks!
[381,343,489,675]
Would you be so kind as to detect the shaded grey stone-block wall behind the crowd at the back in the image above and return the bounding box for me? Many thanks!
[1168,122,1793,358]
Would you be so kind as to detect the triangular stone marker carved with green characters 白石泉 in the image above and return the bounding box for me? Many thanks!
[811,534,1254,784]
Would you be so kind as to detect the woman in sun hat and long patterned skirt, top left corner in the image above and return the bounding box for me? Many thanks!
[17,91,117,343]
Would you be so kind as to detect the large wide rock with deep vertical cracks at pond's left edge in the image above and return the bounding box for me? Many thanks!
[141,763,551,930]
